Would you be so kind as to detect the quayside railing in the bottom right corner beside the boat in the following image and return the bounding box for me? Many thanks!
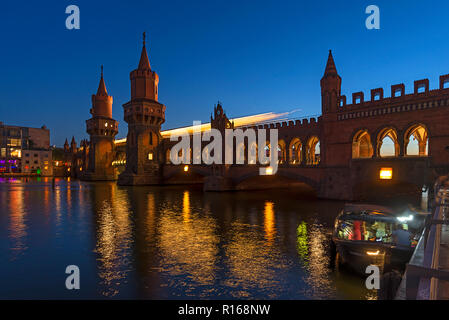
[405,180,449,300]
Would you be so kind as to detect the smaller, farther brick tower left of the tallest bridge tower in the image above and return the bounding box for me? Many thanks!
[81,66,118,180]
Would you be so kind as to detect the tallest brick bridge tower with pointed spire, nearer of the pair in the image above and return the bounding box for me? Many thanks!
[118,33,165,185]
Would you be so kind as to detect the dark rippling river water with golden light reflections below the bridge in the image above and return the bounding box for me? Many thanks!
[0,178,388,299]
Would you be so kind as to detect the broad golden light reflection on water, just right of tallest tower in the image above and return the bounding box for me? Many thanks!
[158,191,219,296]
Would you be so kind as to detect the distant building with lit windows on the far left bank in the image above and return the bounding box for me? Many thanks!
[0,122,53,176]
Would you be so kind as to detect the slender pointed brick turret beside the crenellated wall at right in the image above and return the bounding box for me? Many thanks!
[321,50,341,114]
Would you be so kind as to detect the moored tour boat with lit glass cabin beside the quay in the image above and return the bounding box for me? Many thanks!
[332,204,426,273]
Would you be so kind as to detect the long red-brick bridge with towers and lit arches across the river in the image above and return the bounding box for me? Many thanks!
[64,37,449,200]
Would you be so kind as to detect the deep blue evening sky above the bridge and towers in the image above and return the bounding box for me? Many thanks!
[0,0,449,146]
